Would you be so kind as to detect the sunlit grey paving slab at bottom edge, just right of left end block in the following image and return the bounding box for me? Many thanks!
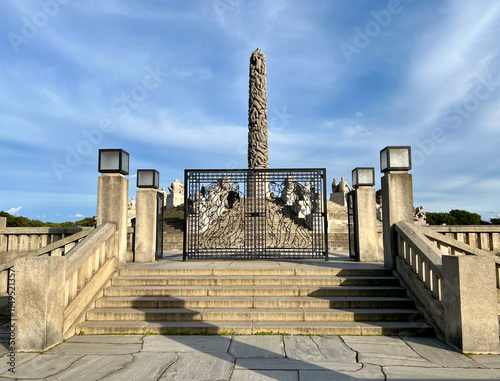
[46,355,133,381]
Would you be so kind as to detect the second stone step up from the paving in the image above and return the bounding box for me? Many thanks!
[87,308,422,322]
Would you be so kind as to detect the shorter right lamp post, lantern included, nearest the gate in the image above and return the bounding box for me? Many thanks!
[352,167,380,262]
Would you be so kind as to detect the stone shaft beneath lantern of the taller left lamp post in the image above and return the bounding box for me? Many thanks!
[97,173,128,267]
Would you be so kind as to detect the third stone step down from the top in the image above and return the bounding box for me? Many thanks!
[104,286,405,297]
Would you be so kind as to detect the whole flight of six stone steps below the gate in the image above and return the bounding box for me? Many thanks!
[76,262,433,336]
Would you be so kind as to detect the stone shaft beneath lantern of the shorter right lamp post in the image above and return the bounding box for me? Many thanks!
[354,186,381,262]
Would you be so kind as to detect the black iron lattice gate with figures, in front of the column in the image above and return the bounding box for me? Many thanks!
[184,169,328,260]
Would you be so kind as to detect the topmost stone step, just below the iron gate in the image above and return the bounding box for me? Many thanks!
[119,268,391,277]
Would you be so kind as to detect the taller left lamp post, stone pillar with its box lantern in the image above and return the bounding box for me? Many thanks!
[97,149,129,267]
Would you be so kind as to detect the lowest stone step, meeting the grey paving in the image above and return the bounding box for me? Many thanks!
[76,320,434,336]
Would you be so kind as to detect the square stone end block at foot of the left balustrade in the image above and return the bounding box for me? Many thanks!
[13,257,66,351]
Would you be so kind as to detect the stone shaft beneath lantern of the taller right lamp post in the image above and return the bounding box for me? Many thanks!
[382,171,413,268]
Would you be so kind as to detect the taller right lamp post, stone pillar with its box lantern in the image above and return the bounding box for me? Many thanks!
[380,146,413,268]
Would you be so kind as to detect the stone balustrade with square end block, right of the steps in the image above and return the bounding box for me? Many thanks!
[394,222,500,353]
